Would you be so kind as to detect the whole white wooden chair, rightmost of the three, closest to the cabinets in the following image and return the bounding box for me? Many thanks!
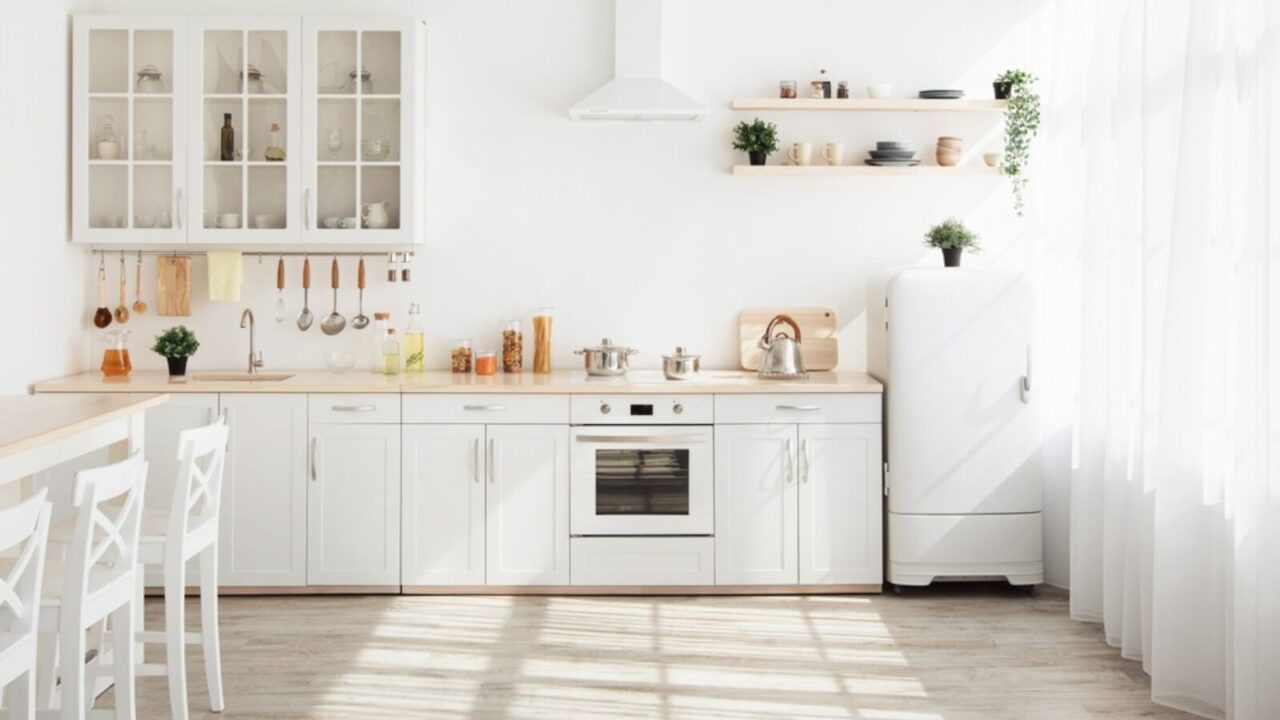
[137,418,227,720]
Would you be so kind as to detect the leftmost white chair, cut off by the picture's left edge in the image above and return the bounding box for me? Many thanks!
[0,488,52,720]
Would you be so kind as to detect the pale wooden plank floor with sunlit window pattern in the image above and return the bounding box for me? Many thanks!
[102,585,1188,720]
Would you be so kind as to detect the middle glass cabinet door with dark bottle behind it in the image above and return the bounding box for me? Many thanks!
[188,18,302,245]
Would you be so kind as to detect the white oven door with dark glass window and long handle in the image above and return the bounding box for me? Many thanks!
[570,425,714,536]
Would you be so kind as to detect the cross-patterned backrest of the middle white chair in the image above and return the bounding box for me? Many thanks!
[63,450,147,602]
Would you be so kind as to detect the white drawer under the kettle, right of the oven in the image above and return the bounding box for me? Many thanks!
[716,392,881,424]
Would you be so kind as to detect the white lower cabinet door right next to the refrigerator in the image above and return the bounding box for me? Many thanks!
[799,424,884,585]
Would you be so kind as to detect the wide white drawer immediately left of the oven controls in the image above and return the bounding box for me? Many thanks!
[404,393,568,425]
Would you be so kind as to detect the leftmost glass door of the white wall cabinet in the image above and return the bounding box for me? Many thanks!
[72,17,187,243]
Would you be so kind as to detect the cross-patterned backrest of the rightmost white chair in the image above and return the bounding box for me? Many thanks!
[168,416,228,539]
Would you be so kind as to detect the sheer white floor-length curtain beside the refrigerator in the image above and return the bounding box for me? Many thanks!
[1032,0,1280,720]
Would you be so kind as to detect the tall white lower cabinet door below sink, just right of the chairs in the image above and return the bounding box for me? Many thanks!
[218,393,307,587]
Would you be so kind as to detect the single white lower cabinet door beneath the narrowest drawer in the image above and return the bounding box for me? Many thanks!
[307,424,401,585]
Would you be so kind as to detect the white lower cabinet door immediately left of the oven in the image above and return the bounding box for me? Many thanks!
[485,425,570,585]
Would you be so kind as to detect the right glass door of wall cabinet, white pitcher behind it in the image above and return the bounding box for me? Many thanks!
[303,18,421,243]
